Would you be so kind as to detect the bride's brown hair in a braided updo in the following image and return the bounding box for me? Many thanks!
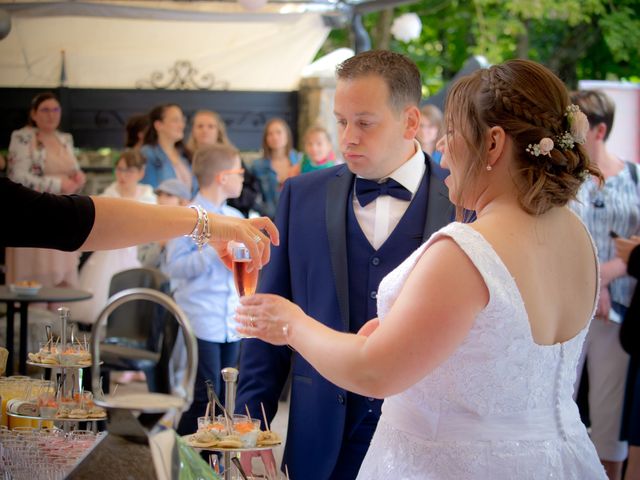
[445,60,600,215]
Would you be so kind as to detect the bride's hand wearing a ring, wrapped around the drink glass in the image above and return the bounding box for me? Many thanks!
[236,294,308,345]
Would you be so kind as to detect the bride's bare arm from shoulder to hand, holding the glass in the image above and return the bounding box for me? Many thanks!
[238,238,489,398]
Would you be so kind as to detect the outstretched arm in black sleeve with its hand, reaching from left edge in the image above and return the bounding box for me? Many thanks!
[0,178,278,268]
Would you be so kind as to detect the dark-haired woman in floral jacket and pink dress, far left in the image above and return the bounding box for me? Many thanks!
[5,92,85,287]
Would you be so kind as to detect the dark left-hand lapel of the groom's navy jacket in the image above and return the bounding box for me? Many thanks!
[325,167,354,331]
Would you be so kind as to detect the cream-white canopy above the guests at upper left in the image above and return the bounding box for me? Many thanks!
[0,0,329,91]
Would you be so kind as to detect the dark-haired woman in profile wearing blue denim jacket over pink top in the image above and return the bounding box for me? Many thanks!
[141,103,198,194]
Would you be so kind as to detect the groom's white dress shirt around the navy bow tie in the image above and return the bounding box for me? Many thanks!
[353,140,426,250]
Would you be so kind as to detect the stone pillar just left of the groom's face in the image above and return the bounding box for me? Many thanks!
[298,77,342,161]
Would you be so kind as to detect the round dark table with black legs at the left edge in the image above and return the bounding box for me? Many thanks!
[0,285,93,376]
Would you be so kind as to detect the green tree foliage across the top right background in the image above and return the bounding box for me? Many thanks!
[321,0,640,95]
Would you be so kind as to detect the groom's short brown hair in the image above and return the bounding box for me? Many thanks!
[336,50,422,110]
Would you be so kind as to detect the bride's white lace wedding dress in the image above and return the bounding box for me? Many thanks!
[358,223,606,480]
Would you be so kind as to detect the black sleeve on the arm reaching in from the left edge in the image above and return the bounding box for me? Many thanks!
[0,178,95,252]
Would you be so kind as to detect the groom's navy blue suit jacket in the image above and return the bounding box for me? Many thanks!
[236,156,453,480]
